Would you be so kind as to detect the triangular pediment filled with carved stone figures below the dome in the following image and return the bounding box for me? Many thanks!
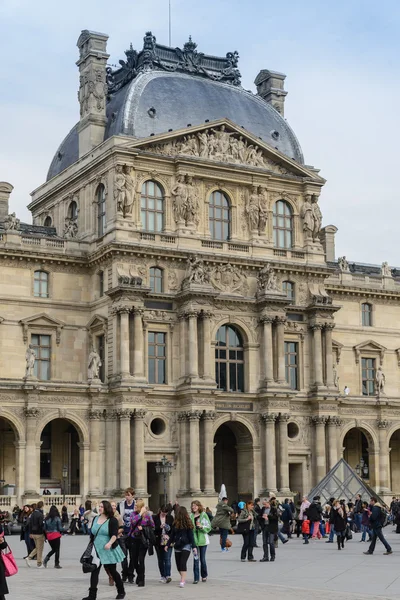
[132,119,324,182]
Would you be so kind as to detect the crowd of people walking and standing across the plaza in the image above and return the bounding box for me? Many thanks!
[0,488,400,600]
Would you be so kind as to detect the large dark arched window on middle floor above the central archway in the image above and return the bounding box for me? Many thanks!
[215,325,244,392]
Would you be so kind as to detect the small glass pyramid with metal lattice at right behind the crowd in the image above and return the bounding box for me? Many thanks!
[308,458,385,506]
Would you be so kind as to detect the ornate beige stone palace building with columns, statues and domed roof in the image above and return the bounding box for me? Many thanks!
[0,31,400,508]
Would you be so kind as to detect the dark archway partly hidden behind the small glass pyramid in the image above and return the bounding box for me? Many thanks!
[343,427,376,487]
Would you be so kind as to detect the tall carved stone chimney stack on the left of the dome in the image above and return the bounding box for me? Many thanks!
[76,29,109,157]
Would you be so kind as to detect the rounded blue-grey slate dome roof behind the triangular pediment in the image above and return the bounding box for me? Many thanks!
[47,71,304,180]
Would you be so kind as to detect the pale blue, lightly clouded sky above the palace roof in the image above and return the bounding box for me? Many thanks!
[0,0,400,266]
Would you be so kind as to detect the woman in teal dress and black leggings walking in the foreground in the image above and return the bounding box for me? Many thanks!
[82,500,125,600]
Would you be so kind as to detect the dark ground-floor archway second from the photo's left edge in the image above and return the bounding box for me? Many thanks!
[40,419,80,495]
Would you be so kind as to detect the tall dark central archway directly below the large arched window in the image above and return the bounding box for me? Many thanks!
[214,421,254,503]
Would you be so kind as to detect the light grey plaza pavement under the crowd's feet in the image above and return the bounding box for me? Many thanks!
[6,527,400,600]
